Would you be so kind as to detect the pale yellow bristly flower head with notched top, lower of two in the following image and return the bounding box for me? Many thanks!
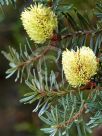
[62,46,97,87]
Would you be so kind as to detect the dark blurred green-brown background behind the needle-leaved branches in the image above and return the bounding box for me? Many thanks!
[0,0,96,136]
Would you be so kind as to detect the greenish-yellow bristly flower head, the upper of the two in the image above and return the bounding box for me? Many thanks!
[21,4,57,43]
